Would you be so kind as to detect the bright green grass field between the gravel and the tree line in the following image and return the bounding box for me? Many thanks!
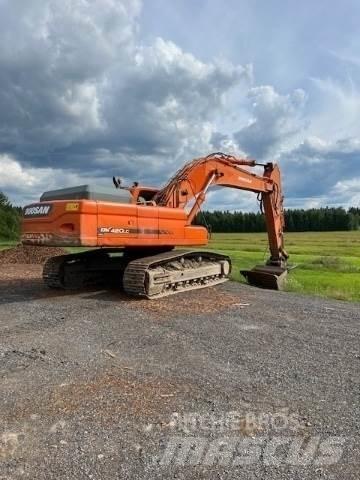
[0,231,360,301]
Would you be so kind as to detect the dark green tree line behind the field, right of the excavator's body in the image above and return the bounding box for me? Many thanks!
[196,207,360,233]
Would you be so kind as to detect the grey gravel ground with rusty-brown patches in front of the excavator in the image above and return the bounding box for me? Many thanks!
[0,265,360,480]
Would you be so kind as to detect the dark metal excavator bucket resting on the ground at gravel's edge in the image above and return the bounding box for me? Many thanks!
[240,265,288,290]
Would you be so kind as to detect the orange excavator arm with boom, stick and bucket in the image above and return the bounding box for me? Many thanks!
[154,153,288,289]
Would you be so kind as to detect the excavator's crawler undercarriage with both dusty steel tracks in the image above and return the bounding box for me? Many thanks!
[43,249,231,298]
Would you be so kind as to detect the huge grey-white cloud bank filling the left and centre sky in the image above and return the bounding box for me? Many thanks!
[0,0,251,197]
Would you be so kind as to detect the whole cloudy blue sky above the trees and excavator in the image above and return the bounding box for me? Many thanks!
[0,0,360,210]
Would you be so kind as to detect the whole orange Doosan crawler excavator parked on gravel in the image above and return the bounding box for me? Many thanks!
[21,152,288,299]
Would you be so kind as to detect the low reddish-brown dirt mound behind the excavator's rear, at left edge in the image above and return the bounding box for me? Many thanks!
[0,245,68,265]
